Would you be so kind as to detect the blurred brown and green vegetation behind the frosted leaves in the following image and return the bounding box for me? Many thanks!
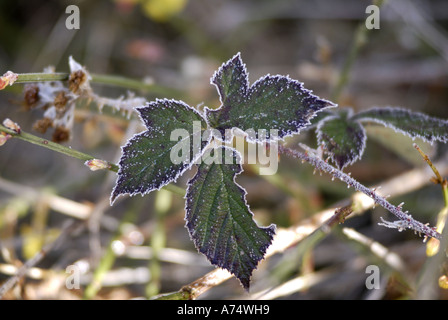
[0,0,448,299]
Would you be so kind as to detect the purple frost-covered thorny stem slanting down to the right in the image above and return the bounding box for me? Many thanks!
[278,145,441,240]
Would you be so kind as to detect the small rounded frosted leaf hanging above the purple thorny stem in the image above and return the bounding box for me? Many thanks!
[317,109,367,169]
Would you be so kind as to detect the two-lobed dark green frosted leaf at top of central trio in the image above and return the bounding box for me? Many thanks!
[205,54,335,141]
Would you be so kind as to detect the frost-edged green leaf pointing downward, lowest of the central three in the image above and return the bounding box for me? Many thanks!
[185,147,275,290]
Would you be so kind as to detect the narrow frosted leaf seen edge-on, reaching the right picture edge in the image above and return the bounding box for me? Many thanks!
[352,107,448,143]
